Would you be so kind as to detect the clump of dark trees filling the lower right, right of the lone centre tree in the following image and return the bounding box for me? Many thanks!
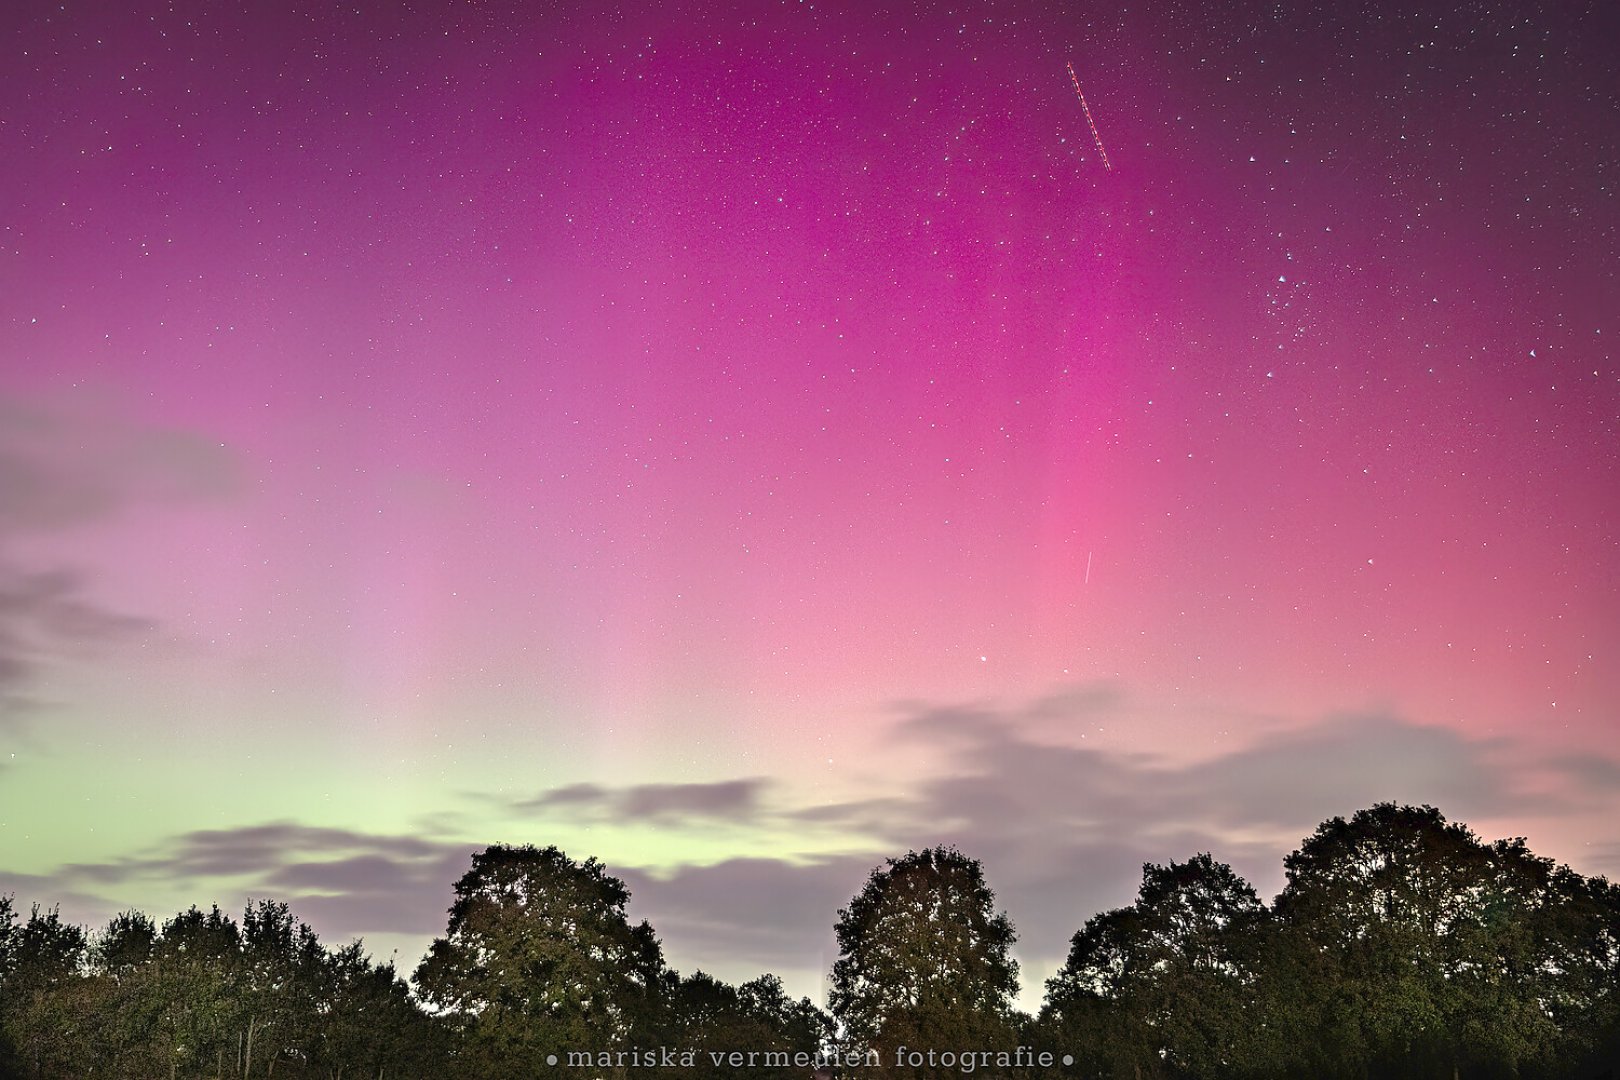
[1032,803,1620,1080]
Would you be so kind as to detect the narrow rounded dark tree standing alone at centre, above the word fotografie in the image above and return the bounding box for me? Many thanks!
[829,847,1017,1075]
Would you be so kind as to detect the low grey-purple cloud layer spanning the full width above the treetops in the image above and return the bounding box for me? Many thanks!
[0,691,1617,1003]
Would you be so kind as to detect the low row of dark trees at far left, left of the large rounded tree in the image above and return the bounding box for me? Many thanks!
[0,897,444,1080]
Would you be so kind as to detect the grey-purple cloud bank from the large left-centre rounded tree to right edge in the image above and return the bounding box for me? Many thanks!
[603,688,1617,983]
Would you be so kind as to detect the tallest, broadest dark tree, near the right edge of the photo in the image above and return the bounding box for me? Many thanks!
[1268,803,1615,1078]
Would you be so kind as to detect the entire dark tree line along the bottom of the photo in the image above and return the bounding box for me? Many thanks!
[0,803,1620,1080]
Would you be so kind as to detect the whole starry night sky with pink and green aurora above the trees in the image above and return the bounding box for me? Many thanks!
[0,0,1620,1002]
